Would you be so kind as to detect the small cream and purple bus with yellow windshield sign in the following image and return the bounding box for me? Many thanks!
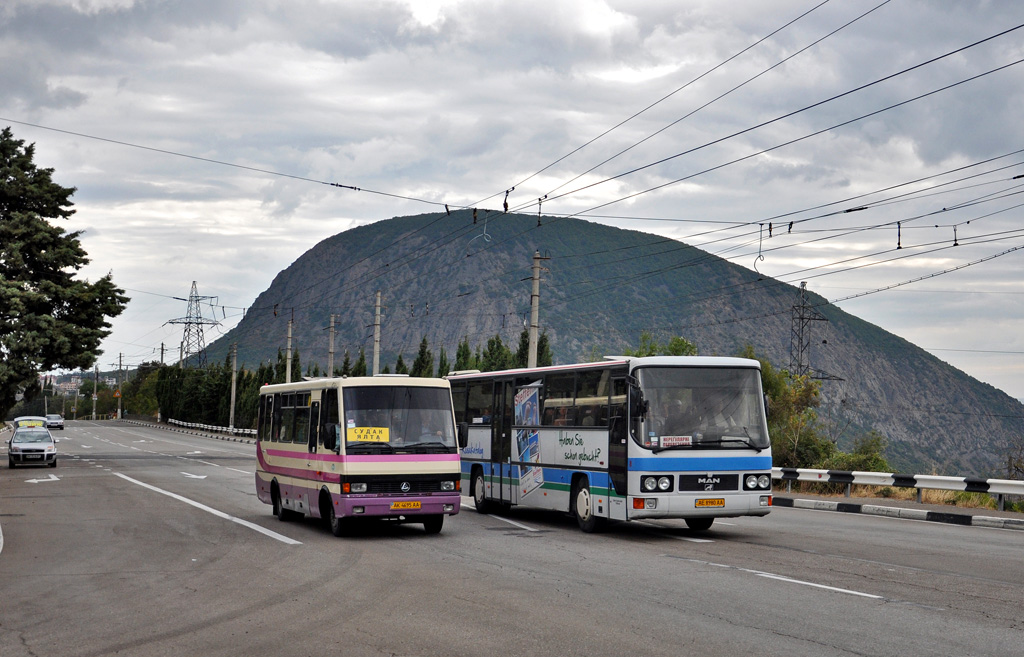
[256,376,461,536]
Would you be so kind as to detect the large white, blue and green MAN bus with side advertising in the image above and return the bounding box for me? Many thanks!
[447,356,772,532]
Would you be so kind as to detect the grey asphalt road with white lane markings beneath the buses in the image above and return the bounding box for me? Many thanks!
[0,422,1024,657]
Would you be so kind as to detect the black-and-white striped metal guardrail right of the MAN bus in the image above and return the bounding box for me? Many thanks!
[771,468,1024,511]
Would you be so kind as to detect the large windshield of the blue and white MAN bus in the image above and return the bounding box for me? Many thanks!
[633,367,769,451]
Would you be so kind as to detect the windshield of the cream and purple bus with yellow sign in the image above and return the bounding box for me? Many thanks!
[342,386,457,453]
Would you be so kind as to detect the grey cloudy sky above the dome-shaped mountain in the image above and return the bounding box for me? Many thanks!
[6,0,1024,398]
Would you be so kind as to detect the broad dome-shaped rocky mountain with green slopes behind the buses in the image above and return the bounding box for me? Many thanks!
[208,210,1024,476]
